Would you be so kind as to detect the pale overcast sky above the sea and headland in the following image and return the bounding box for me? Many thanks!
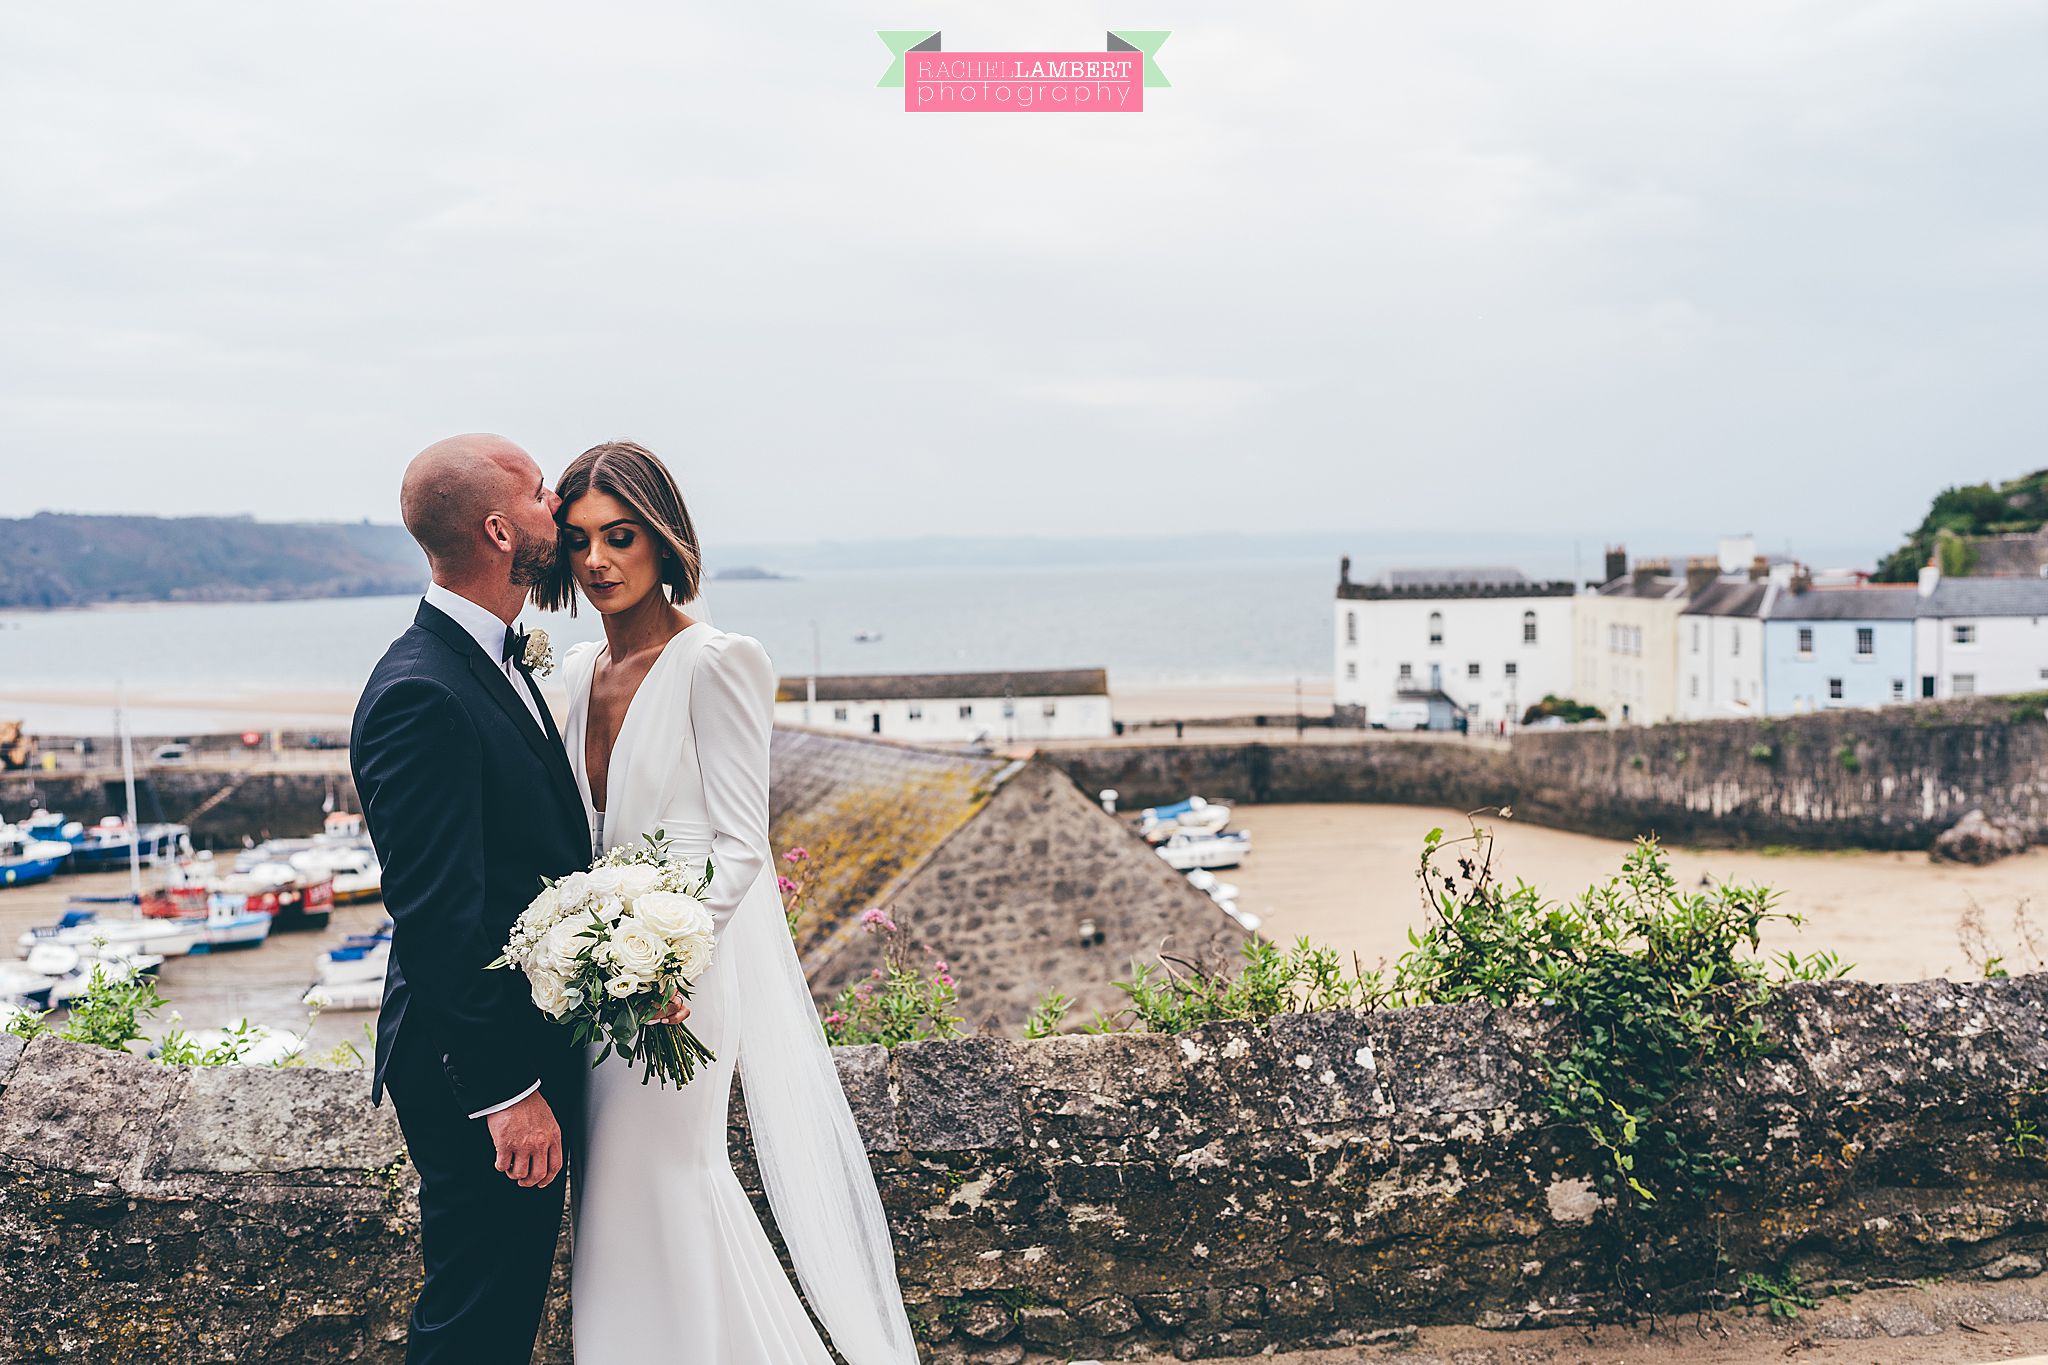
[0,0,2048,544]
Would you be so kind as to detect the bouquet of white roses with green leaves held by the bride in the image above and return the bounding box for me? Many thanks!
[485,829,713,1085]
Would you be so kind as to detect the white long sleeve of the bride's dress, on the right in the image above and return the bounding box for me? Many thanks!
[690,634,774,937]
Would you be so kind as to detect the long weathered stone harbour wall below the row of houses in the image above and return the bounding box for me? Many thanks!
[1047,698,2048,849]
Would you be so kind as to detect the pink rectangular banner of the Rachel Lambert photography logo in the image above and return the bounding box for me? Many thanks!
[903,51,1145,115]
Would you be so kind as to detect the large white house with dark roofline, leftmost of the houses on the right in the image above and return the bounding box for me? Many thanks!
[1333,559,1575,731]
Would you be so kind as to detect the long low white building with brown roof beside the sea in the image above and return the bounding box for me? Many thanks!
[774,669,1112,745]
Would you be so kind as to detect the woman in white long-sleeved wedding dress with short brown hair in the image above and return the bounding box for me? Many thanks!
[535,442,918,1365]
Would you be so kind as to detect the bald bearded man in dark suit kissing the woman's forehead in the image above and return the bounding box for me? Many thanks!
[348,436,590,1365]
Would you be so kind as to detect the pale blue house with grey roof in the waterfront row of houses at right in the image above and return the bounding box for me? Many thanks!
[1763,583,1921,716]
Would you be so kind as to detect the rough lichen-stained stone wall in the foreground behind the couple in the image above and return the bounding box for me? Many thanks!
[0,978,2048,1365]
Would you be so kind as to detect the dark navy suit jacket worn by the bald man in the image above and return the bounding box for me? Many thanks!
[348,602,590,1111]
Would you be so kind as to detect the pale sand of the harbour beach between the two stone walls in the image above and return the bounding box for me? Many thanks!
[1219,806,2048,980]
